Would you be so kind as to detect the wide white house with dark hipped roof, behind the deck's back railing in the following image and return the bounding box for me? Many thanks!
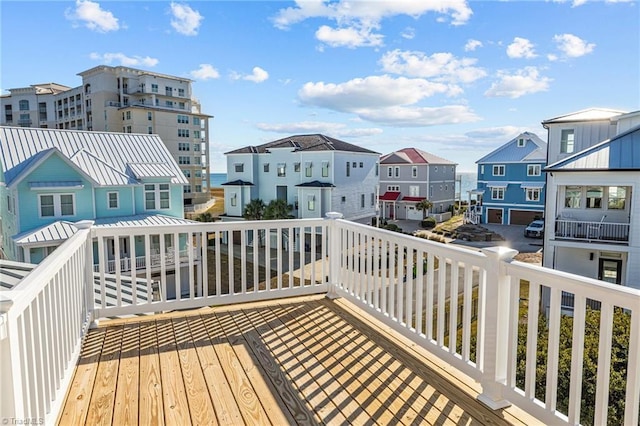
[223,134,380,220]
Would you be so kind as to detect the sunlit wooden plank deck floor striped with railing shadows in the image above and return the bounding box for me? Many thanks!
[58,297,535,425]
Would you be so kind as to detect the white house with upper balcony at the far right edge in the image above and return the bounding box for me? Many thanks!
[543,109,640,288]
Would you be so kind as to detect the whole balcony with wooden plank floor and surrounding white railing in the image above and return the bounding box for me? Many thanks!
[0,218,640,425]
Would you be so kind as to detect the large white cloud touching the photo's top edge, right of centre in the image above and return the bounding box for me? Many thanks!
[272,0,472,48]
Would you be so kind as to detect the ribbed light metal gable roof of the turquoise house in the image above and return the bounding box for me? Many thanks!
[0,126,188,186]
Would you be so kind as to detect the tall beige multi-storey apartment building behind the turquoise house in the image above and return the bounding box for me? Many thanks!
[0,65,211,209]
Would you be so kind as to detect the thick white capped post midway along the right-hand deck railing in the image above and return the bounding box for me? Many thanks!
[478,247,518,410]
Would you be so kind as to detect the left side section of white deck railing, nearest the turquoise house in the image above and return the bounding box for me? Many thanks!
[0,222,92,424]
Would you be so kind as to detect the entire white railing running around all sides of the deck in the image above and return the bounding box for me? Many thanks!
[0,218,640,425]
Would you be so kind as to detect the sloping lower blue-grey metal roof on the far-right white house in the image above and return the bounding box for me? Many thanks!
[545,126,640,172]
